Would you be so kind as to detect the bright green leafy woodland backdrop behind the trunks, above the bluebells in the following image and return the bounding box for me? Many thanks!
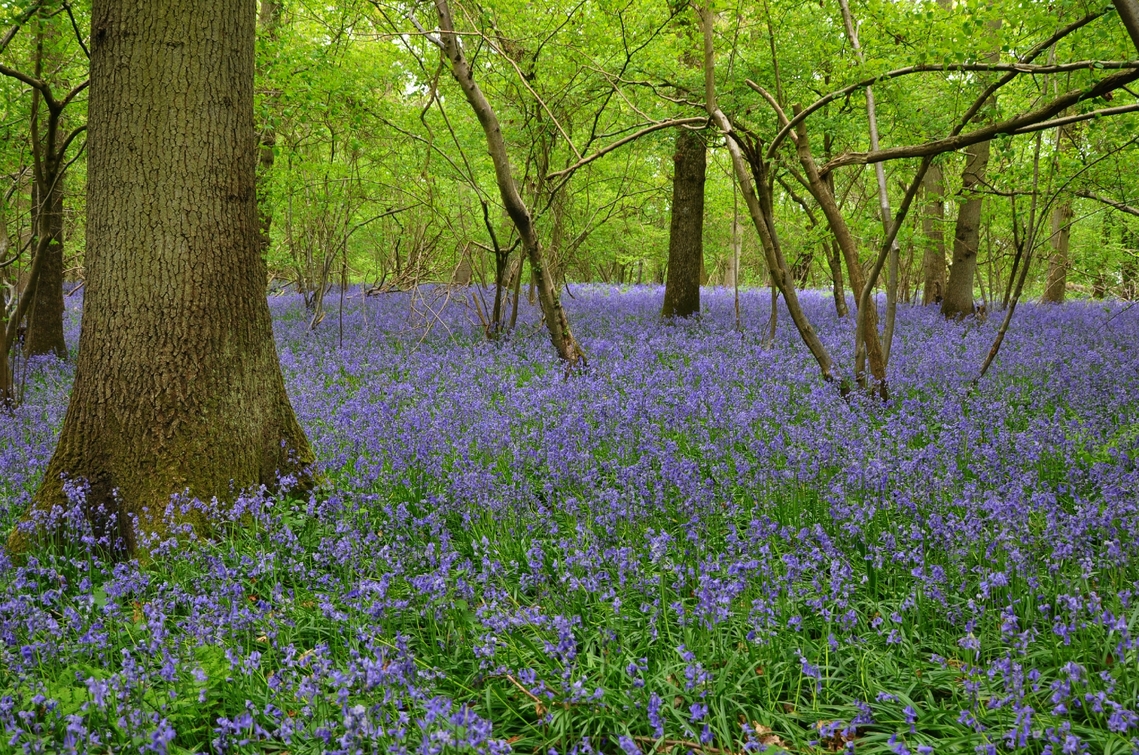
[0,0,1139,353]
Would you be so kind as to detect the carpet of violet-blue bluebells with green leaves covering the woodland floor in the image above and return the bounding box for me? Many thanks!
[0,287,1139,755]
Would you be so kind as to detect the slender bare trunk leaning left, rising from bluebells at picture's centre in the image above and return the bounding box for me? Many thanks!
[435,0,585,368]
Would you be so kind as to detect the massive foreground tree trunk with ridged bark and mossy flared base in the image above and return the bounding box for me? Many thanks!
[21,0,312,551]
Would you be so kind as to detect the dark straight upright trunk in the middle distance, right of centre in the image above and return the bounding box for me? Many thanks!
[661,129,707,318]
